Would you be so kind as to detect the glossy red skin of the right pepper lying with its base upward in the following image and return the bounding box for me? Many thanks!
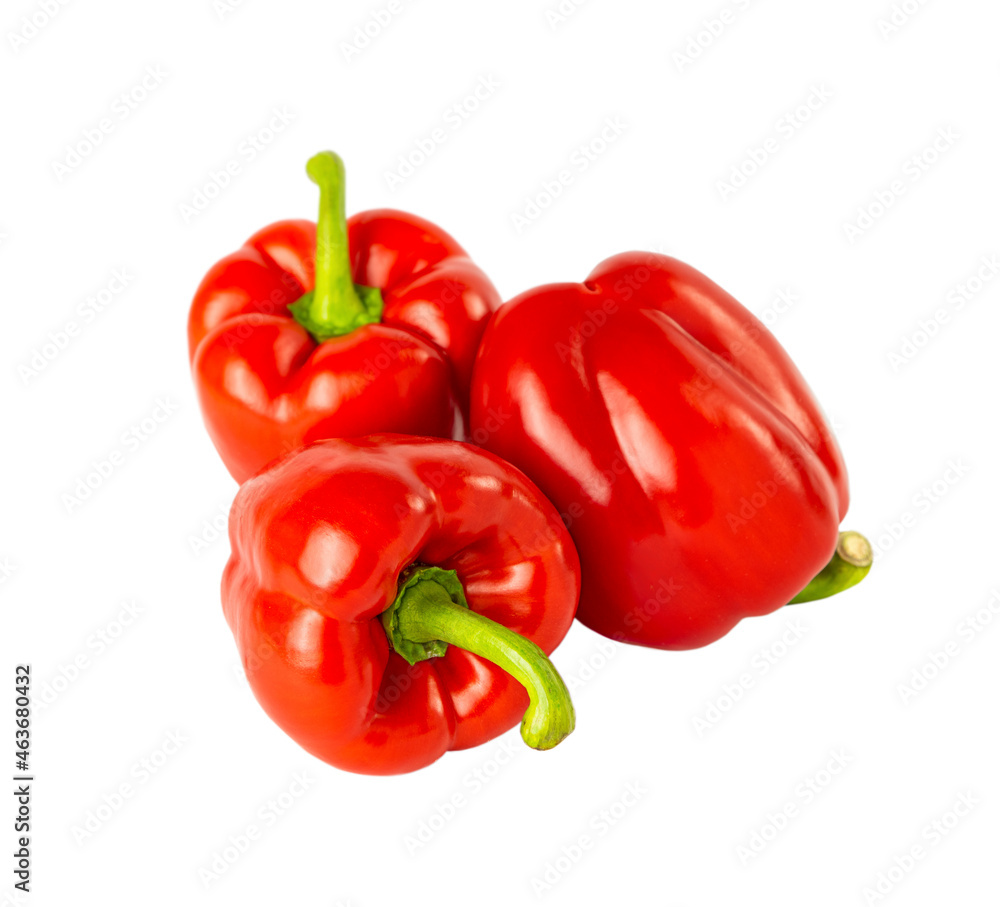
[472,253,848,649]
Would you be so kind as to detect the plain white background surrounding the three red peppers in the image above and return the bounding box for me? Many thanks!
[0,0,1000,907]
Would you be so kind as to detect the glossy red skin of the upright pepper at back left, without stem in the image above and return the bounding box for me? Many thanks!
[188,211,500,482]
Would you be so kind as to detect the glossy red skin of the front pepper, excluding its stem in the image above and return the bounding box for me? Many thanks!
[222,435,580,775]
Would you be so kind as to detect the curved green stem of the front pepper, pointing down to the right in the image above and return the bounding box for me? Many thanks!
[382,567,576,750]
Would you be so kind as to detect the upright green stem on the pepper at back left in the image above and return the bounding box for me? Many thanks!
[289,151,383,343]
